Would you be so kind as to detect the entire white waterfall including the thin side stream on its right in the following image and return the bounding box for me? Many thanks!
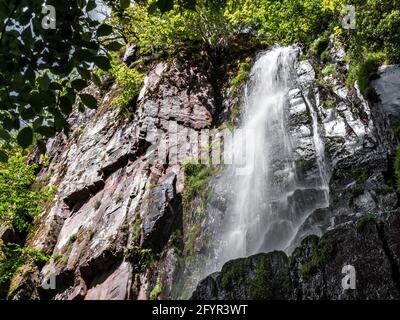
[177,47,328,298]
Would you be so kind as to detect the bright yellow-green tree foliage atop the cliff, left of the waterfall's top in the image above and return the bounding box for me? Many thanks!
[113,0,226,53]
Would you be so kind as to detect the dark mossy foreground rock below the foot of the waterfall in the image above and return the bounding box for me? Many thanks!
[192,211,400,300]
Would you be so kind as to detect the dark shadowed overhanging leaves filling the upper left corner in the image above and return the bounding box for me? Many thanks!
[0,0,128,151]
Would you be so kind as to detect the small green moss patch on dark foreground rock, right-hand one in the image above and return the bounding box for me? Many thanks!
[300,237,336,278]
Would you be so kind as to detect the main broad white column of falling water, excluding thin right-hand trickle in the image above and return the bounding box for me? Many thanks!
[217,48,297,267]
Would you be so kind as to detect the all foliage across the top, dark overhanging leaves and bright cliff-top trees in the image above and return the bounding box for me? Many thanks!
[0,0,400,154]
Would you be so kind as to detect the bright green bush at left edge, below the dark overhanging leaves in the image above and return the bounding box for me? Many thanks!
[0,147,54,232]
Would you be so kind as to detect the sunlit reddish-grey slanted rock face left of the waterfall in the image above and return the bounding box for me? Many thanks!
[7,52,219,299]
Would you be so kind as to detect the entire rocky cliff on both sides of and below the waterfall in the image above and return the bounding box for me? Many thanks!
[5,38,400,299]
